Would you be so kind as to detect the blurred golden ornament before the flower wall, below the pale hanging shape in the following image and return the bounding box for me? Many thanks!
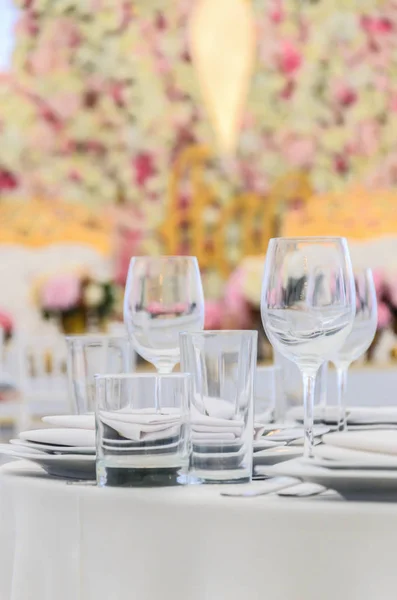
[159,146,312,278]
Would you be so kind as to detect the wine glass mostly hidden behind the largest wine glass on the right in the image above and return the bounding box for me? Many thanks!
[330,269,378,431]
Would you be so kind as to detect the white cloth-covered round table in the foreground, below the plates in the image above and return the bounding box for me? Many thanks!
[0,461,397,600]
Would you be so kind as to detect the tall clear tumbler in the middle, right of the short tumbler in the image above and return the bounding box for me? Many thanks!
[180,331,258,483]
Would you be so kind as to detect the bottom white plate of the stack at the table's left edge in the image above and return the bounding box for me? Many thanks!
[0,444,96,479]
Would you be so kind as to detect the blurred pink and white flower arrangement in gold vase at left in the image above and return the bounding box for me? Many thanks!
[38,273,115,333]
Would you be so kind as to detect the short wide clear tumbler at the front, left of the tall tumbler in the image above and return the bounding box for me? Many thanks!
[95,373,191,487]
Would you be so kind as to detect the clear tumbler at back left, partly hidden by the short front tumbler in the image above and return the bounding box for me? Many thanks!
[66,335,136,414]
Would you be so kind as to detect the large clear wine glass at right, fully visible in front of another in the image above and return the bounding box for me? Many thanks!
[261,237,355,457]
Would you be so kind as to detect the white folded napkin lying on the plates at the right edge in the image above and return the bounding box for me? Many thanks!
[323,430,397,455]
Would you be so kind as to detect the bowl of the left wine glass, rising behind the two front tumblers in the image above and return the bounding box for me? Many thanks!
[124,256,204,373]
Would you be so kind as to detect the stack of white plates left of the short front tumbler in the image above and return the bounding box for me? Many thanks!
[0,415,95,479]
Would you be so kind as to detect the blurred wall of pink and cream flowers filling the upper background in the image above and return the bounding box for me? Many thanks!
[0,0,397,268]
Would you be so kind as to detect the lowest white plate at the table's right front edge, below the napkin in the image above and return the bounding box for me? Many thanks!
[256,459,397,502]
